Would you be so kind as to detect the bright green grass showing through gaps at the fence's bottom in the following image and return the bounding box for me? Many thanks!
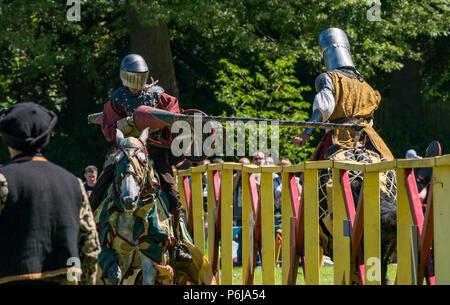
[222,265,397,285]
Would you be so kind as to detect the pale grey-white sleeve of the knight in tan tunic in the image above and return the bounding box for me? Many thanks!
[313,73,335,122]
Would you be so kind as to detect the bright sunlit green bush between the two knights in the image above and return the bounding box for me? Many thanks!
[215,56,311,160]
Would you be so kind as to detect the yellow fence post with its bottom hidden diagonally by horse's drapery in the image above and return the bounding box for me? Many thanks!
[191,167,206,254]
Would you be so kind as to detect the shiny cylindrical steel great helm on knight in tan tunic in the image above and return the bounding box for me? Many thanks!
[319,28,355,71]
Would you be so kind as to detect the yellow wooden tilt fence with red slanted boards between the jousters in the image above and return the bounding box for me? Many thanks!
[176,155,450,285]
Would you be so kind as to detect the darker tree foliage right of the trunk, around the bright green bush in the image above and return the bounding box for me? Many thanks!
[169,0,450,161]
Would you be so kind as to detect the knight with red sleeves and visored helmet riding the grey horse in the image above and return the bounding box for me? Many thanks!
[96,54,191,262]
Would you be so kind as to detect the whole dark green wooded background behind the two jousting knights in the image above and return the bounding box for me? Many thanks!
[0,0,450,176]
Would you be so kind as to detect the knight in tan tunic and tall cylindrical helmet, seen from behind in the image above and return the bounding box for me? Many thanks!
[293,28,394,160]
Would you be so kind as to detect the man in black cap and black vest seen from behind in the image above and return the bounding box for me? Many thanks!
[0,102,100,284]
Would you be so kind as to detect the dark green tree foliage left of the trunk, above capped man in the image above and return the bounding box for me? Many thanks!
[0,0,127,175]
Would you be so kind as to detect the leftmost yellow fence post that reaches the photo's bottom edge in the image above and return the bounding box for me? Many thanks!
[220,163,233,285]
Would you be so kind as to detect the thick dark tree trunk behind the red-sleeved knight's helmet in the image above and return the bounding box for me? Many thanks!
[127,1,178,97]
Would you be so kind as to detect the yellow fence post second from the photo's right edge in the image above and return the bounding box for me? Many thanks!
[397,168,414,285]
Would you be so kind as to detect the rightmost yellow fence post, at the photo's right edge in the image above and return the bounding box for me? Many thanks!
[433,155,450,285]
